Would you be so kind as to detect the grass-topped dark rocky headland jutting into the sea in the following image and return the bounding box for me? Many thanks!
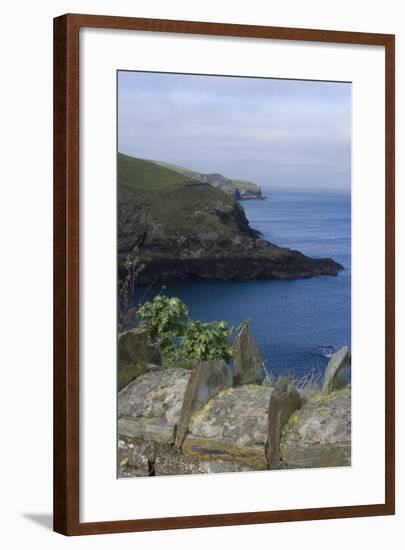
[118,155,342,284]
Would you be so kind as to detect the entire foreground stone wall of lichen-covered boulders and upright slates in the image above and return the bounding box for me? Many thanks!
[118,327,351,477]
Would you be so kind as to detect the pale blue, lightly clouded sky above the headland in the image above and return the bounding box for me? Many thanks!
[118,71,351,191]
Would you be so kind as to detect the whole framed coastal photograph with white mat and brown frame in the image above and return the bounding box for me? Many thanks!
[54,15,395,535]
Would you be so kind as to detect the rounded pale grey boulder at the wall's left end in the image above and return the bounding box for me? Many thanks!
[118,368,190,442]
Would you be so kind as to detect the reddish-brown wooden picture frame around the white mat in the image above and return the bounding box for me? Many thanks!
[54,14,395,535]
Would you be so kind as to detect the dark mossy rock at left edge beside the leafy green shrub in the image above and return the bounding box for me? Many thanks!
[118,328,162,391]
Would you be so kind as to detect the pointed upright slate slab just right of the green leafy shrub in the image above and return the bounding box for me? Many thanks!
[233,326,266,385]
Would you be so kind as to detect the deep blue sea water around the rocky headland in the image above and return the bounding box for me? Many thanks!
[137,189,351,376]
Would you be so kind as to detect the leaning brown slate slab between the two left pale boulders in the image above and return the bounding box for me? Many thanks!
[175,359,232,448]
